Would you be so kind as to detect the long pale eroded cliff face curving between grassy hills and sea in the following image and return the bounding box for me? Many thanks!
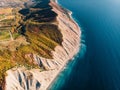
[5,0,81,90]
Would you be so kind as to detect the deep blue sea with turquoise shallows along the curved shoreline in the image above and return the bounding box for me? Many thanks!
[50,0,120,90]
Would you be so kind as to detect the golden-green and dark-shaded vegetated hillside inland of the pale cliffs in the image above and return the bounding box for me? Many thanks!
[0,0,62,88]
